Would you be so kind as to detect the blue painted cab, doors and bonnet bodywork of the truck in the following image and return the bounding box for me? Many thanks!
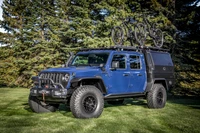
[41,50,147,95]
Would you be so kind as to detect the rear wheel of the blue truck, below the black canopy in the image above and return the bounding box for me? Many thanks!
[147,84,167,108]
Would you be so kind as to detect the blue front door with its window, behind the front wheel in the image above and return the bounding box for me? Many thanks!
[108,53,130,94]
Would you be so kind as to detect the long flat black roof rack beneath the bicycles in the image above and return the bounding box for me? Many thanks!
[80,45,169,52]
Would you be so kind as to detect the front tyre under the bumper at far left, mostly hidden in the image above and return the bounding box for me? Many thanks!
[28,95,59,113]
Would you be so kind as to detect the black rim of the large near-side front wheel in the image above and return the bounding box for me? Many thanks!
[83,96,97,113]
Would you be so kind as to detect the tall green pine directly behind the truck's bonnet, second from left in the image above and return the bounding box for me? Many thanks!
[12,0,69,86]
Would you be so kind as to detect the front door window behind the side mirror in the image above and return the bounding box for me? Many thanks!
[111,55,126,69]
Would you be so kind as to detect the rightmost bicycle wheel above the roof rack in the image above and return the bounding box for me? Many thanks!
[153,29,164,48]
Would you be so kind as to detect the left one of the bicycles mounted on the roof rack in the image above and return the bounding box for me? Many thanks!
[111,18,138,46]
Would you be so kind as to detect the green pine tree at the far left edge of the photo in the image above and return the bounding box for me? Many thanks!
[0,0,25,86]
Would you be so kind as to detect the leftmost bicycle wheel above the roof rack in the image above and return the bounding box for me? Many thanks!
[111,26,124,45]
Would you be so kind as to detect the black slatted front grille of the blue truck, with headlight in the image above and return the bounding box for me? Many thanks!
[40,72,67,88]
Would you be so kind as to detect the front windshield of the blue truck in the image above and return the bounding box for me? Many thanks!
[71,53,109,66]
